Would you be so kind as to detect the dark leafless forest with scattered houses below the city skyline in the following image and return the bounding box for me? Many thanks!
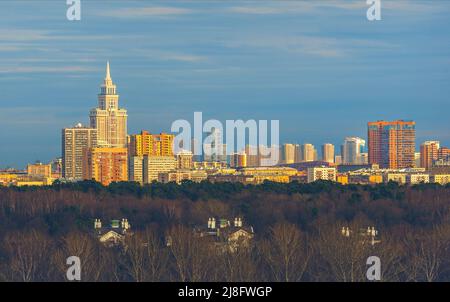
[0,181,450,282]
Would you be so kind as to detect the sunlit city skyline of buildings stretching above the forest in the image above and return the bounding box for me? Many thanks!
[0,63,450,186]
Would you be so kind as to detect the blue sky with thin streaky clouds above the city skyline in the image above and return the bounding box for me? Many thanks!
[0,0,450,168]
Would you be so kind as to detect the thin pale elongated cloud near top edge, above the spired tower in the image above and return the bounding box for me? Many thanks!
[97,6,193,18]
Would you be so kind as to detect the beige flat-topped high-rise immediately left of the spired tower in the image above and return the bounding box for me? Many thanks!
[62,124,97,179]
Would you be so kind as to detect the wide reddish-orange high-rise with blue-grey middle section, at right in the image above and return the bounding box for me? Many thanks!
[367,120,416,169]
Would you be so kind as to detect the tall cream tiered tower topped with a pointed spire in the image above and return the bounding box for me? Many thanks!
[90,62,127,148]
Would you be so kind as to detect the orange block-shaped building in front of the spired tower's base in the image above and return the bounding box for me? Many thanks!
[83,147,128,186]
